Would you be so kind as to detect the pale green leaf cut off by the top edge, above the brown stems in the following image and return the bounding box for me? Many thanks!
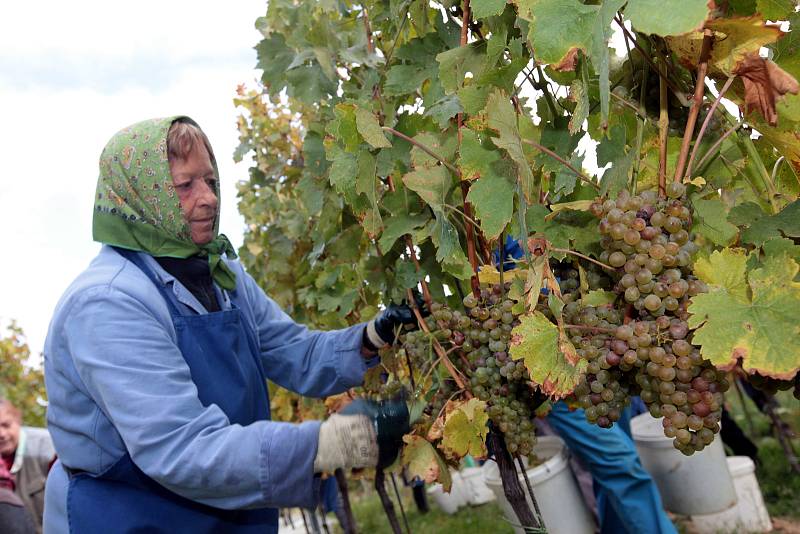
[625,0,709,37]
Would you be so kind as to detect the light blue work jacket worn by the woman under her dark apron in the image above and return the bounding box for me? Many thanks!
[45,246,368,533]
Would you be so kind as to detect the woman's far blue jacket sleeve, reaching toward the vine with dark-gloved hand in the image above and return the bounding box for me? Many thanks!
[240,271,377,397]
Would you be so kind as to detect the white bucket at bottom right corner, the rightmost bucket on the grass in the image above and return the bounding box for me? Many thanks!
[691,456,772,534]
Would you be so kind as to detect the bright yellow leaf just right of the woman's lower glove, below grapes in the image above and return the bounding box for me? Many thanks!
[441,397,489,458]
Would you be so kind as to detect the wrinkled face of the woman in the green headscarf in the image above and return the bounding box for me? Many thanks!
[169,143,218,245]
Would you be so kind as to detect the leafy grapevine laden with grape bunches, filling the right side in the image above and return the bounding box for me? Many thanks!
[237,0,800,526]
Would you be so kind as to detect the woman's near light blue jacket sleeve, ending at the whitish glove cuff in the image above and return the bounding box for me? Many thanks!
[63,286,319,509]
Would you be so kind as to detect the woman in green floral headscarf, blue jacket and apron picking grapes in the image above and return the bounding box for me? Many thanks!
[44,117,412,534]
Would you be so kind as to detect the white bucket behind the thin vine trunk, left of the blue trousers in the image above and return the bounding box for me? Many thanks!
[482,436,595,534]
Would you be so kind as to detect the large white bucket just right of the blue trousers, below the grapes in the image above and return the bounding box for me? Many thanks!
[631,413,736,515]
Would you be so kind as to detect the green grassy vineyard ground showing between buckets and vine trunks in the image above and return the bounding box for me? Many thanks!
[336,392,800,534]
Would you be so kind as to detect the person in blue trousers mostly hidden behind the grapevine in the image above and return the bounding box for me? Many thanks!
[495,237,677,534]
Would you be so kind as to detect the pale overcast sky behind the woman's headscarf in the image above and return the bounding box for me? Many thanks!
[0,0,266,353]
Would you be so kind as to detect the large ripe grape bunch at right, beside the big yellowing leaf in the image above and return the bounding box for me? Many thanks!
[576,183,729,454]
